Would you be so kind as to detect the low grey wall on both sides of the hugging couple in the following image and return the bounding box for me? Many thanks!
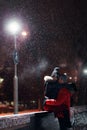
[0,106,87,130]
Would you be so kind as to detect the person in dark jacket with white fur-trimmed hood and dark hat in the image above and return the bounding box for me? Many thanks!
[44,67,60,103]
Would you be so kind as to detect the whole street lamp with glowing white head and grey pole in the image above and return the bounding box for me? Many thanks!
[7,20,21,114]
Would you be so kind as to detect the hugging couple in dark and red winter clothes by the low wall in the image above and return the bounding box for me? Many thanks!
[44,67,76,130]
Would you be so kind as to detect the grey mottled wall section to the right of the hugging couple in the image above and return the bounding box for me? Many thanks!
[71,106,87,130]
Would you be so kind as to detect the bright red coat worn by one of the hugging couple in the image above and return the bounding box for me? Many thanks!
[44,88,71,117]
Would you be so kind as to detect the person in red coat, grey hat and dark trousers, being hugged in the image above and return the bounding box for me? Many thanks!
[44,74,74,130]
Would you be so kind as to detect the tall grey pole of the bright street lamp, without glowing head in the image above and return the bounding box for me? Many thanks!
[14,35,18,114]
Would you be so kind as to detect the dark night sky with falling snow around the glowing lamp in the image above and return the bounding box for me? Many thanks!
[0,0,87,102]
